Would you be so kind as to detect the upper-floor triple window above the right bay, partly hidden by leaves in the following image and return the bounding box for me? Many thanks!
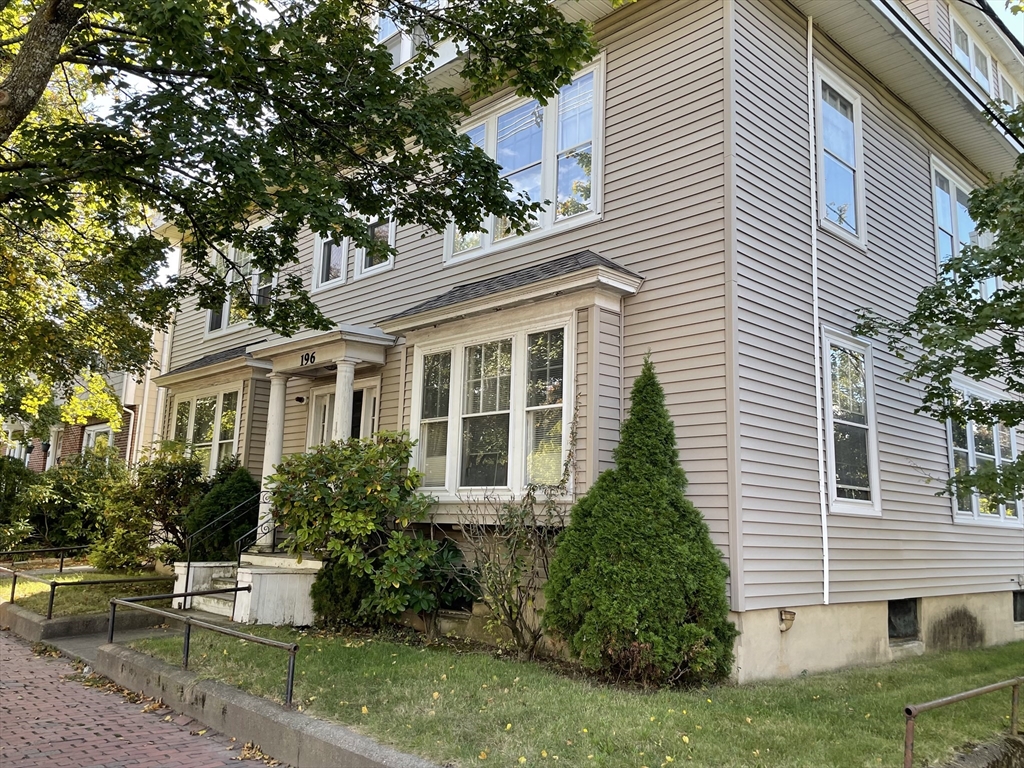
[444,66,601,260]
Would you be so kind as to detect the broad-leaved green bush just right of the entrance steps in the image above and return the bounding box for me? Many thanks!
[271,432,448,621]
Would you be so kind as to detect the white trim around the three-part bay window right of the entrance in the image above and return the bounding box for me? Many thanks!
[410,312,577,503]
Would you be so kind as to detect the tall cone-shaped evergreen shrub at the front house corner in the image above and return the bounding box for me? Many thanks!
[544,357,736,684]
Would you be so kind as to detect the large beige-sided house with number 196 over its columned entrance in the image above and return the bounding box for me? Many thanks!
[153,0,1024,680]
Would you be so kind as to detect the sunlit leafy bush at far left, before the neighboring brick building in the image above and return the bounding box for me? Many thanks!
[29,446,128,547]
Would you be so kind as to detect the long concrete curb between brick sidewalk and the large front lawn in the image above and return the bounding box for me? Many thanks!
[94,643,437,768]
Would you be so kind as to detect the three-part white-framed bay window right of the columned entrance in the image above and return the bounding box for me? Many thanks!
[414,325,571,495]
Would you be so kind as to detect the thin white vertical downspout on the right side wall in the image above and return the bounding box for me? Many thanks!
[807,16,829,605]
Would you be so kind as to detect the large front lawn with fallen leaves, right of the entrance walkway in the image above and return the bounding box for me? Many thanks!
[132,627,1024,768]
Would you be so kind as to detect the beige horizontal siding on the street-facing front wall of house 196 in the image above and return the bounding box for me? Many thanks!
[163,0,728,554]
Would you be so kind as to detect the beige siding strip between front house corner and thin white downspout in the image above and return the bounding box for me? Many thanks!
[734,0,823,609]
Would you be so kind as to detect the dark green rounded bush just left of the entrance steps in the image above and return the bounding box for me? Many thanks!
[183,459,260,561]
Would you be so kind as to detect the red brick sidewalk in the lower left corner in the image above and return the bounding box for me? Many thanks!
[0,632,268,768]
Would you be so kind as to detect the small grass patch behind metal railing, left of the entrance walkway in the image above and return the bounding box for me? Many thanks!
[0,571,174,617]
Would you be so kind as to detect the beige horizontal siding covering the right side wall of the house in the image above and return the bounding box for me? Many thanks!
[736,0,1024,609]
